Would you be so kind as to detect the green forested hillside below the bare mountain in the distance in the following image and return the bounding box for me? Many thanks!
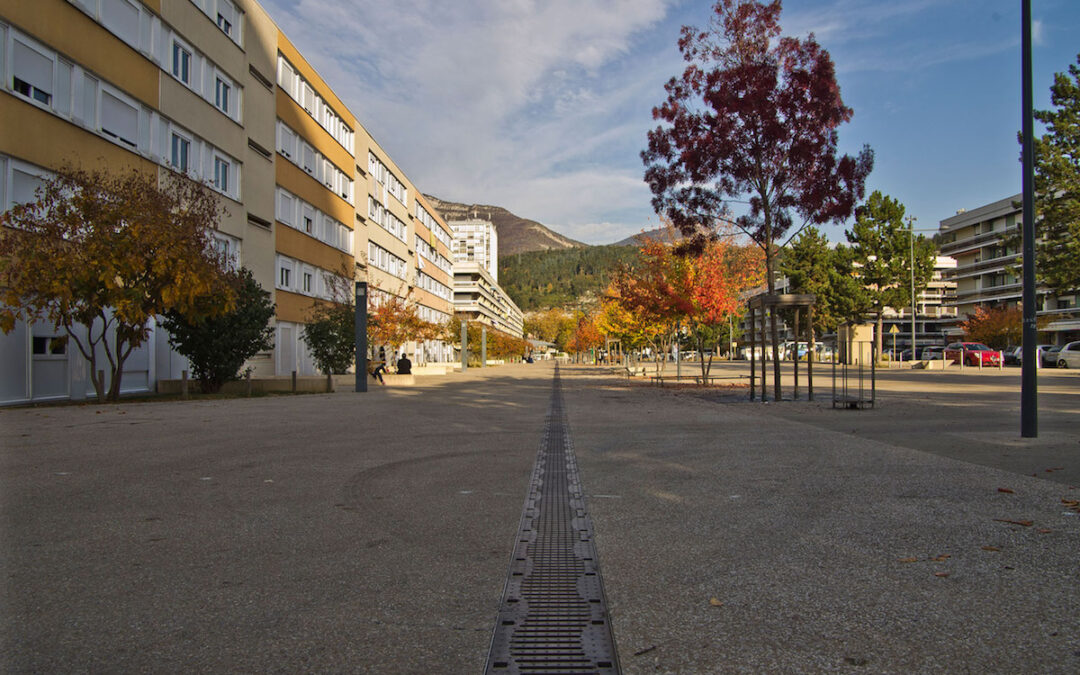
[499,245,637,312]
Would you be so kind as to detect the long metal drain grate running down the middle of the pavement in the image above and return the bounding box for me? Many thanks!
[486,365,620,674]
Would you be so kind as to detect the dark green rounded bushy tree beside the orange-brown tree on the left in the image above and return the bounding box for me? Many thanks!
[161,268,274,393]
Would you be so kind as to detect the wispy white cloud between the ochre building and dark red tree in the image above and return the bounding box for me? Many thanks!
[258,0,680,241]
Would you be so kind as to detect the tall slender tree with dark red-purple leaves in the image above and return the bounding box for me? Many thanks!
[642,0,874,401]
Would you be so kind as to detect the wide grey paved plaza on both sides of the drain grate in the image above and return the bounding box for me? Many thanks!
[0,363,1080,673]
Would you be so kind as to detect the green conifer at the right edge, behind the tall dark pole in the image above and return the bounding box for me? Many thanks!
[1035,55,1080,295]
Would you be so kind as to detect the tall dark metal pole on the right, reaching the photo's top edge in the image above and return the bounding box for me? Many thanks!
[1020,0,1039,438]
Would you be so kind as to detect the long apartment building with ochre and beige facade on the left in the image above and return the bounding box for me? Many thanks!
[0,0,454,403]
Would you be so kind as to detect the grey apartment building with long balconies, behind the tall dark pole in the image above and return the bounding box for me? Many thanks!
[939,194,1080,342]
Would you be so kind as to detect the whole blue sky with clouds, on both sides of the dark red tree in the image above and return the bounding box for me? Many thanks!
[261,0,1080,244]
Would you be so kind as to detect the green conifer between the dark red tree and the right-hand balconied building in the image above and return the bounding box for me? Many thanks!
[847,190,935,354]
